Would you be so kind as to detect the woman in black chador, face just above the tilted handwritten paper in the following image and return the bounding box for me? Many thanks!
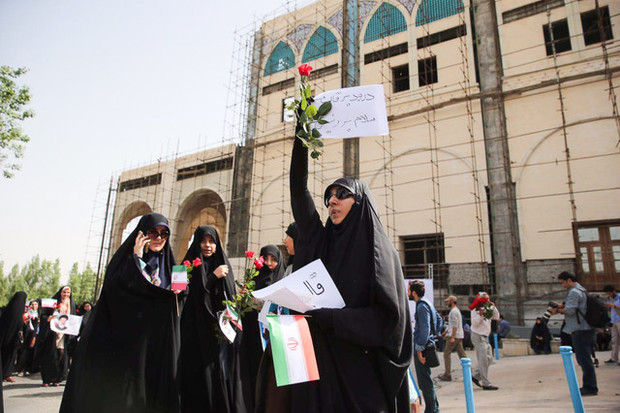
[235,244,286,413]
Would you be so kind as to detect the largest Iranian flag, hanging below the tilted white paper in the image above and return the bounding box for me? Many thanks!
[267,314,319,386]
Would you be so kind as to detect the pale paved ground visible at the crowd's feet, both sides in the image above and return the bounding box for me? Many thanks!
[4,351,620,413]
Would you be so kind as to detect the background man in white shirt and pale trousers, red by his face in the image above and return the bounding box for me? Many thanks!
[470,292,499,390]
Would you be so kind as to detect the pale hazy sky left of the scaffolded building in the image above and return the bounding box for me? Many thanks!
[0,0,296,274]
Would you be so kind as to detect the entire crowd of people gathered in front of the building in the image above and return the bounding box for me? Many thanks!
[0,135,620,413]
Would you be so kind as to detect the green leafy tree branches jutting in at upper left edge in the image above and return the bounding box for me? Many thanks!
[0,66,34,178]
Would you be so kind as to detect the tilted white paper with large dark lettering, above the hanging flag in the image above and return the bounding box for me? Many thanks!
[252,259,345,313]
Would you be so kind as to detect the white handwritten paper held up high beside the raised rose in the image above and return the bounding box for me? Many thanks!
[313,85,390,139]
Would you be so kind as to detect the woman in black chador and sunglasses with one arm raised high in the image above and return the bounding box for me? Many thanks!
[254,139,413,413]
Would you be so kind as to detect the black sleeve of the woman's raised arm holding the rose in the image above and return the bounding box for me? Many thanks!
[290,138,321,232]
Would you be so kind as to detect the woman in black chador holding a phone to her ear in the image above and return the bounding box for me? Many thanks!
[60,213,182,413]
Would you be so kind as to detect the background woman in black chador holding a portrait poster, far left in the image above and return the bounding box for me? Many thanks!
[37,285,75,387]
